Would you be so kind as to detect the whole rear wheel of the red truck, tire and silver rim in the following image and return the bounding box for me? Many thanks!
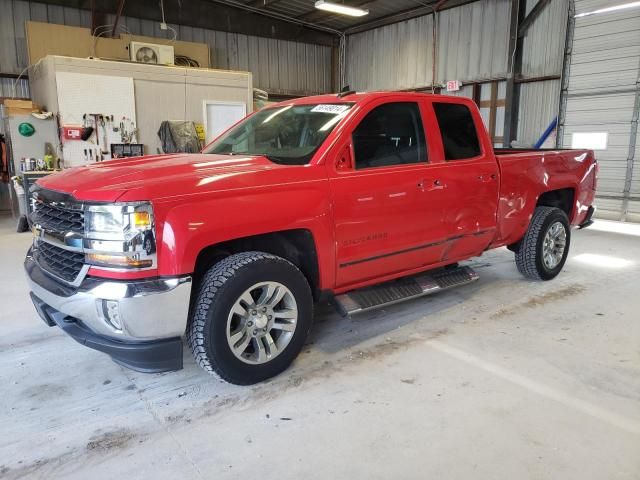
[516,207,571,280]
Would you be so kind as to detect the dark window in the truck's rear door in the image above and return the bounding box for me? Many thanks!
[433,103,480,160]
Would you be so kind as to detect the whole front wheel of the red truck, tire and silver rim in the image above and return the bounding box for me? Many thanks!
[187,252,313,385]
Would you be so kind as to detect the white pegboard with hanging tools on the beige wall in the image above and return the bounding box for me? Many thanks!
[56,72,138,167]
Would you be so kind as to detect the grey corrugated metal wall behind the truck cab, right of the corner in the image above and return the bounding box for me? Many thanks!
[346,0,568,145]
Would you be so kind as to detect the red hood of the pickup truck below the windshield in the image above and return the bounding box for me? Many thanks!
[38,153,296,202]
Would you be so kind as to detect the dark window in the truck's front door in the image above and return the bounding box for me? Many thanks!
[353,102,427,169]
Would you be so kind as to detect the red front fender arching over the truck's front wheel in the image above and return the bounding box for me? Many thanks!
[154,181,335,289]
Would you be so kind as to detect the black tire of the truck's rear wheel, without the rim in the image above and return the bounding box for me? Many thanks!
[515,207,571,280]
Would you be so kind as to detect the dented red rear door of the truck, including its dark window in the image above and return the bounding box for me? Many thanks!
[428,98,500,261]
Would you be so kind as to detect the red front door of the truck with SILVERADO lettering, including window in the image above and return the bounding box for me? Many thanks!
[329,99,442,287]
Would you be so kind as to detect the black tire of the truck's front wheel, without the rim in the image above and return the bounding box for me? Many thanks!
[187,252,313,385]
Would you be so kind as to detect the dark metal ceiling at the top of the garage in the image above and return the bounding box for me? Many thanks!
[27,0,478,46]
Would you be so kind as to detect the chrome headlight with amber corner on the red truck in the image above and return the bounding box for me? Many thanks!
[84,203,156,269]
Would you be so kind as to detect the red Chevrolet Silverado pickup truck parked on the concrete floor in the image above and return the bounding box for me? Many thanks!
[25,92,597,384]
